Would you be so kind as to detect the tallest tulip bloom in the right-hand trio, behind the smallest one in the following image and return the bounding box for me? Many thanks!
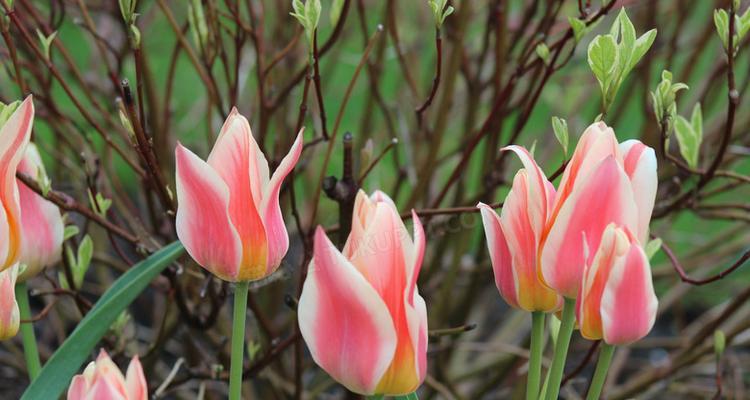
[539,122,657,299]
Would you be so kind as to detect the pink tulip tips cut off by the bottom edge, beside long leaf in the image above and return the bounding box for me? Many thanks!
[68,350,148,400]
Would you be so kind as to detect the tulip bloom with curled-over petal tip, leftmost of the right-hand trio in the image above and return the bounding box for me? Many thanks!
[477,146,561,312]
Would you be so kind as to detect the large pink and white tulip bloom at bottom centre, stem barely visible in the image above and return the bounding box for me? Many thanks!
[297,191,427,395]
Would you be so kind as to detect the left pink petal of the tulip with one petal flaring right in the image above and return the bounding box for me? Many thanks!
[175,144,242,282]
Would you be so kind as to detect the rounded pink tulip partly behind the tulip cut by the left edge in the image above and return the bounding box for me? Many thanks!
[18,143,65,282]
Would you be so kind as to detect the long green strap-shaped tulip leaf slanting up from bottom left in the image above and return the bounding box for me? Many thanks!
[21,242,184,400]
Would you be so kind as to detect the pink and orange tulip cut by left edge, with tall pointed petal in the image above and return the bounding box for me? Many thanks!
[0,95,34,271]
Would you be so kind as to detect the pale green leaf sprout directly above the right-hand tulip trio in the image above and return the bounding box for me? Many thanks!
[588,8,656,113]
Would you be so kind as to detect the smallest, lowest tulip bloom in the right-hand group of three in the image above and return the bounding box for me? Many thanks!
[576,224,658,345]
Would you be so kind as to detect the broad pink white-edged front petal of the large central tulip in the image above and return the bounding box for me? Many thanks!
[298,227,397,394]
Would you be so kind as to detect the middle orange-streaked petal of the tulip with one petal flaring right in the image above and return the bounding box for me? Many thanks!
[206,109,269,281]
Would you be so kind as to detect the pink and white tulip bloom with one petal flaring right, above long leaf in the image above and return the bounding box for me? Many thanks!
[175,108,302,282]
